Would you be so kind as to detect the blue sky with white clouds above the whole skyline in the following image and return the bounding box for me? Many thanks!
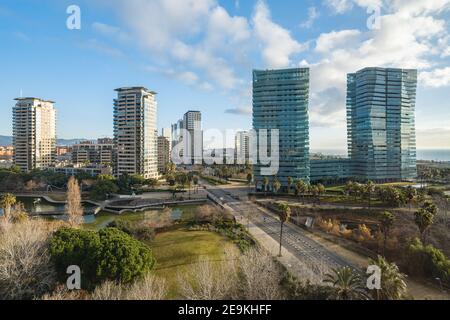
[0,0,450,150]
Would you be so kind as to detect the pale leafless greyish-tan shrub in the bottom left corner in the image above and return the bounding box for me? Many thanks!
[0,220,56,300]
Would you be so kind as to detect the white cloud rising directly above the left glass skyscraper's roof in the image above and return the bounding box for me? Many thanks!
[253,0,308,68]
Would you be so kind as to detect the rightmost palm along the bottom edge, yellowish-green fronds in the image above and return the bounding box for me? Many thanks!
[369,256,407,300]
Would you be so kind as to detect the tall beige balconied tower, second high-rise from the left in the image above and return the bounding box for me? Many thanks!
[114,87,158,179]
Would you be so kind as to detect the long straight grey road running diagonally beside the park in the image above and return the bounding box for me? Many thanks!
[207,185,354,269]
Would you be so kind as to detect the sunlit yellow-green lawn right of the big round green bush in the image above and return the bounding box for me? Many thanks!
[148,229,239,299]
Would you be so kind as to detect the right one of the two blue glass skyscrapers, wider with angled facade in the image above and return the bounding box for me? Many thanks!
[347,68,417,181]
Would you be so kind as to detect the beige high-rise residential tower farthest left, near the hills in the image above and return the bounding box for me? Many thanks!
[13,98,56,171]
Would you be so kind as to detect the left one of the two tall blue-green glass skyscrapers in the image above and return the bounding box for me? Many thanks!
[250,68,310,187]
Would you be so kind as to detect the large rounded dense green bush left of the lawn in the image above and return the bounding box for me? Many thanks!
[50,228,155,289]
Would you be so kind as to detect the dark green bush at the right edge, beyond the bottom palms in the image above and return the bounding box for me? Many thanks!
[407,239,450,286]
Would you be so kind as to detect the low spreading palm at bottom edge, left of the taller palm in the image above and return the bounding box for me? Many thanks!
[324,267,367,300]
